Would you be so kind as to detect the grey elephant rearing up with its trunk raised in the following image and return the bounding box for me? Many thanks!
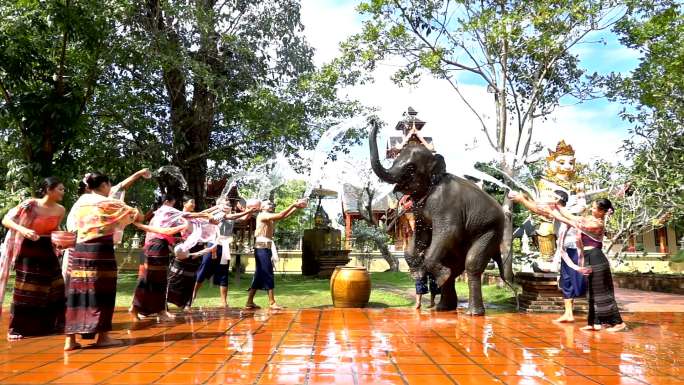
[369,121,505,315]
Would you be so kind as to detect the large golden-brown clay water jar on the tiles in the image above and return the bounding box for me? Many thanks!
[330,266,371,307]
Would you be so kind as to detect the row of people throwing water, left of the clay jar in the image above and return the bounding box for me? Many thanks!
[0,169,307,350]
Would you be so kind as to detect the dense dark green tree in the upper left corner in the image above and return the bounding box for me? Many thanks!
[0,0,119,187]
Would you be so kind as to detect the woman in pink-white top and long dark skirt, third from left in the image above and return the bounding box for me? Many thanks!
[131,195,188,319]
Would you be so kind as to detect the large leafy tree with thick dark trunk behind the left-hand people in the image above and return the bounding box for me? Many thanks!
[107,0,358,207]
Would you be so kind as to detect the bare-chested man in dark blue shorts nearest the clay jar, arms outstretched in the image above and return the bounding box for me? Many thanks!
[245,199,307,309]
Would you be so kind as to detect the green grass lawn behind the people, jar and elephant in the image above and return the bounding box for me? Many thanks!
[4,272,513,310]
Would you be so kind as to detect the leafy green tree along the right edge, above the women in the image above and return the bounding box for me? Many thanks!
[607,1,684,231]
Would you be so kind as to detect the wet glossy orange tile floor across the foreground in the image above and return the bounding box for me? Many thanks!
[0,309,684,385]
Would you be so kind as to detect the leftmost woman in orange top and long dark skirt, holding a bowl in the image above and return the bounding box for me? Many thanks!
[0,177,64,340]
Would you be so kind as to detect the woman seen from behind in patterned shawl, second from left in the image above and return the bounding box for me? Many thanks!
[64,173,142,350]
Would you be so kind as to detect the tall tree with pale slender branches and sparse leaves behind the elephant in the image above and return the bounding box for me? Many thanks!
[343,0,624,279]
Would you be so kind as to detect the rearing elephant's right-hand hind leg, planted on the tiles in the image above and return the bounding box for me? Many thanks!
[465,231,501,315]
